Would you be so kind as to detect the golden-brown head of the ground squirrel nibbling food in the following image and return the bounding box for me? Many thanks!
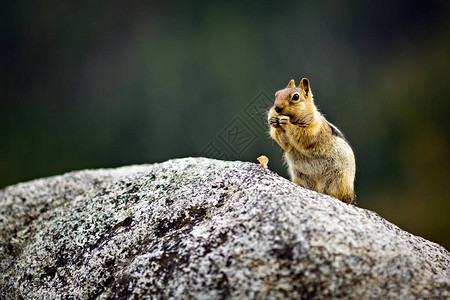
[272,78,316,126]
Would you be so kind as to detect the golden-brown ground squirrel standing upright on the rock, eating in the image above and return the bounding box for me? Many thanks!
[268,78,356,203]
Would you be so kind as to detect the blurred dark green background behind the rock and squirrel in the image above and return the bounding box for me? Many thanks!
[0,0,450,249]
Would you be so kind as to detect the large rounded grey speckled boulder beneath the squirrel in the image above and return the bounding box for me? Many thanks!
[0,158,450,299]
